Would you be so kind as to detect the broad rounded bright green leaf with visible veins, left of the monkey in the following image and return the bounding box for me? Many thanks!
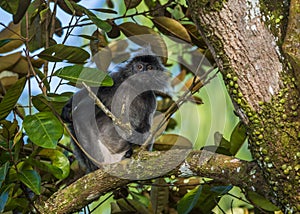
[23,112,63,149]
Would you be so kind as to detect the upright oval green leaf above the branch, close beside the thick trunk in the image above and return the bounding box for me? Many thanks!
[230,122,247,155]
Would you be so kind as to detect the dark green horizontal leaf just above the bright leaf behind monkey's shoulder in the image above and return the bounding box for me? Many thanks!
[38,44,90,63]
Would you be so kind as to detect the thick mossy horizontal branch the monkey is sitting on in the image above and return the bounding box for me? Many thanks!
[37,149,270,214]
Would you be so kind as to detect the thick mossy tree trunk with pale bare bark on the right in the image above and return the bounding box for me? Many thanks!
[188,0,300,211]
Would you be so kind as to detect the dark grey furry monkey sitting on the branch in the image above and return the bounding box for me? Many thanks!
[61,48,170,173]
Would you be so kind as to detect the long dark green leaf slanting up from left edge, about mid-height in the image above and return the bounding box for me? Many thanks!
[0,78,26,120]
